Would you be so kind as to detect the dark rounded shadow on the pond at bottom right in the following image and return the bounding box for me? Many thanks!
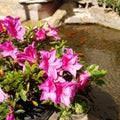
[88,87,119,120]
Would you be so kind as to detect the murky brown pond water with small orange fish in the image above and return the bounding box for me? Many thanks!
[59,24,120,120]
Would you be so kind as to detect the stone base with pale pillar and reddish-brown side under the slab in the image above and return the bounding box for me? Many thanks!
[21,0,61,20]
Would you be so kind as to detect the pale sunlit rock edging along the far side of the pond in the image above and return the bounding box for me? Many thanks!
[48,2,120,30]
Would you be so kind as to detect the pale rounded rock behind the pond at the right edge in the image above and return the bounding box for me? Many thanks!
[90,6,120,30]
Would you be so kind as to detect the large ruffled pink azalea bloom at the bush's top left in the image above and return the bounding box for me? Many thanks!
[3,16,25,41]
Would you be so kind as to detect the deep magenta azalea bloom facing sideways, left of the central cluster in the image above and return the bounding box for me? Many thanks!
[16,43,38,71]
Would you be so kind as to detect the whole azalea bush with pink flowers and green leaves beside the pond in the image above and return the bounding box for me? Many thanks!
[0,16,106,120]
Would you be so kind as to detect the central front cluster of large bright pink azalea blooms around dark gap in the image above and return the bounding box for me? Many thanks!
[39,48,89,106]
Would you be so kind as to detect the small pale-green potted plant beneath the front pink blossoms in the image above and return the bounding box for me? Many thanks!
[59,94,91,120]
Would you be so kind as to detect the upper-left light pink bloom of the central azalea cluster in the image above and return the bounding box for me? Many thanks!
[39,50,62,79]
